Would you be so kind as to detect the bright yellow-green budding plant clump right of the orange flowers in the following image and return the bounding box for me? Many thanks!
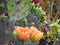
[45,23,59,42]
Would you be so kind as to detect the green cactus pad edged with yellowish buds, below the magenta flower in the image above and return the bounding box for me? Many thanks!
[32,3,46,21]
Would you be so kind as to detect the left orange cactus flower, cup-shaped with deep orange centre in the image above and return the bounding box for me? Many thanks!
[15,26,30,41]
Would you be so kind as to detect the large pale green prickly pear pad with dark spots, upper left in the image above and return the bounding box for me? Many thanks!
[7,0,31,21]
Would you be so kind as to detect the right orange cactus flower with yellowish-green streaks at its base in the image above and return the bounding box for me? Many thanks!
[30,26,43,41]
